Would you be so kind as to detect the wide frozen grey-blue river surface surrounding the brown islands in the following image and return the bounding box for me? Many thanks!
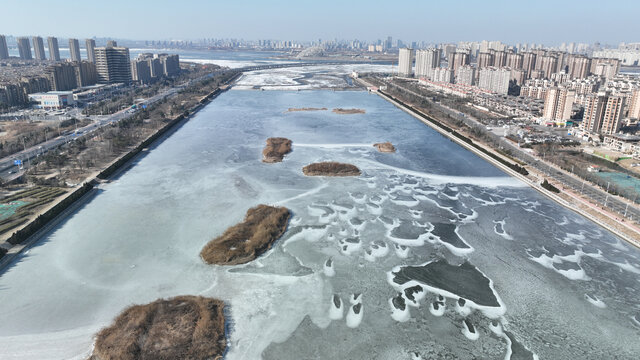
[0,88,640,359]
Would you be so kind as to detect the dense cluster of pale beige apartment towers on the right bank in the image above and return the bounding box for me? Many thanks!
[398,42,640,141]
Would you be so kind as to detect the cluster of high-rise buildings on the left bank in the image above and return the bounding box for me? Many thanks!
[0,35,180,108]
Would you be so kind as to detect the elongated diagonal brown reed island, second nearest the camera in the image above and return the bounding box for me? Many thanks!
[200,205,290,265]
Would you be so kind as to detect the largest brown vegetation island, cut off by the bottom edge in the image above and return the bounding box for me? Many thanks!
[90,296,226,360]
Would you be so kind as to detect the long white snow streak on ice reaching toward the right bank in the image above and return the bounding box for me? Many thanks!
[358,159,528,188]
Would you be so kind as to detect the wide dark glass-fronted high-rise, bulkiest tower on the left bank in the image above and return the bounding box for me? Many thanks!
[95,46,131,84]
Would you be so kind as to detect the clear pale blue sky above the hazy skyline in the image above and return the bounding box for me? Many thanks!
[0,0,640,45]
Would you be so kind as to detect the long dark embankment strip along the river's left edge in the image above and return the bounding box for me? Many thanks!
[0,77,237,271]
